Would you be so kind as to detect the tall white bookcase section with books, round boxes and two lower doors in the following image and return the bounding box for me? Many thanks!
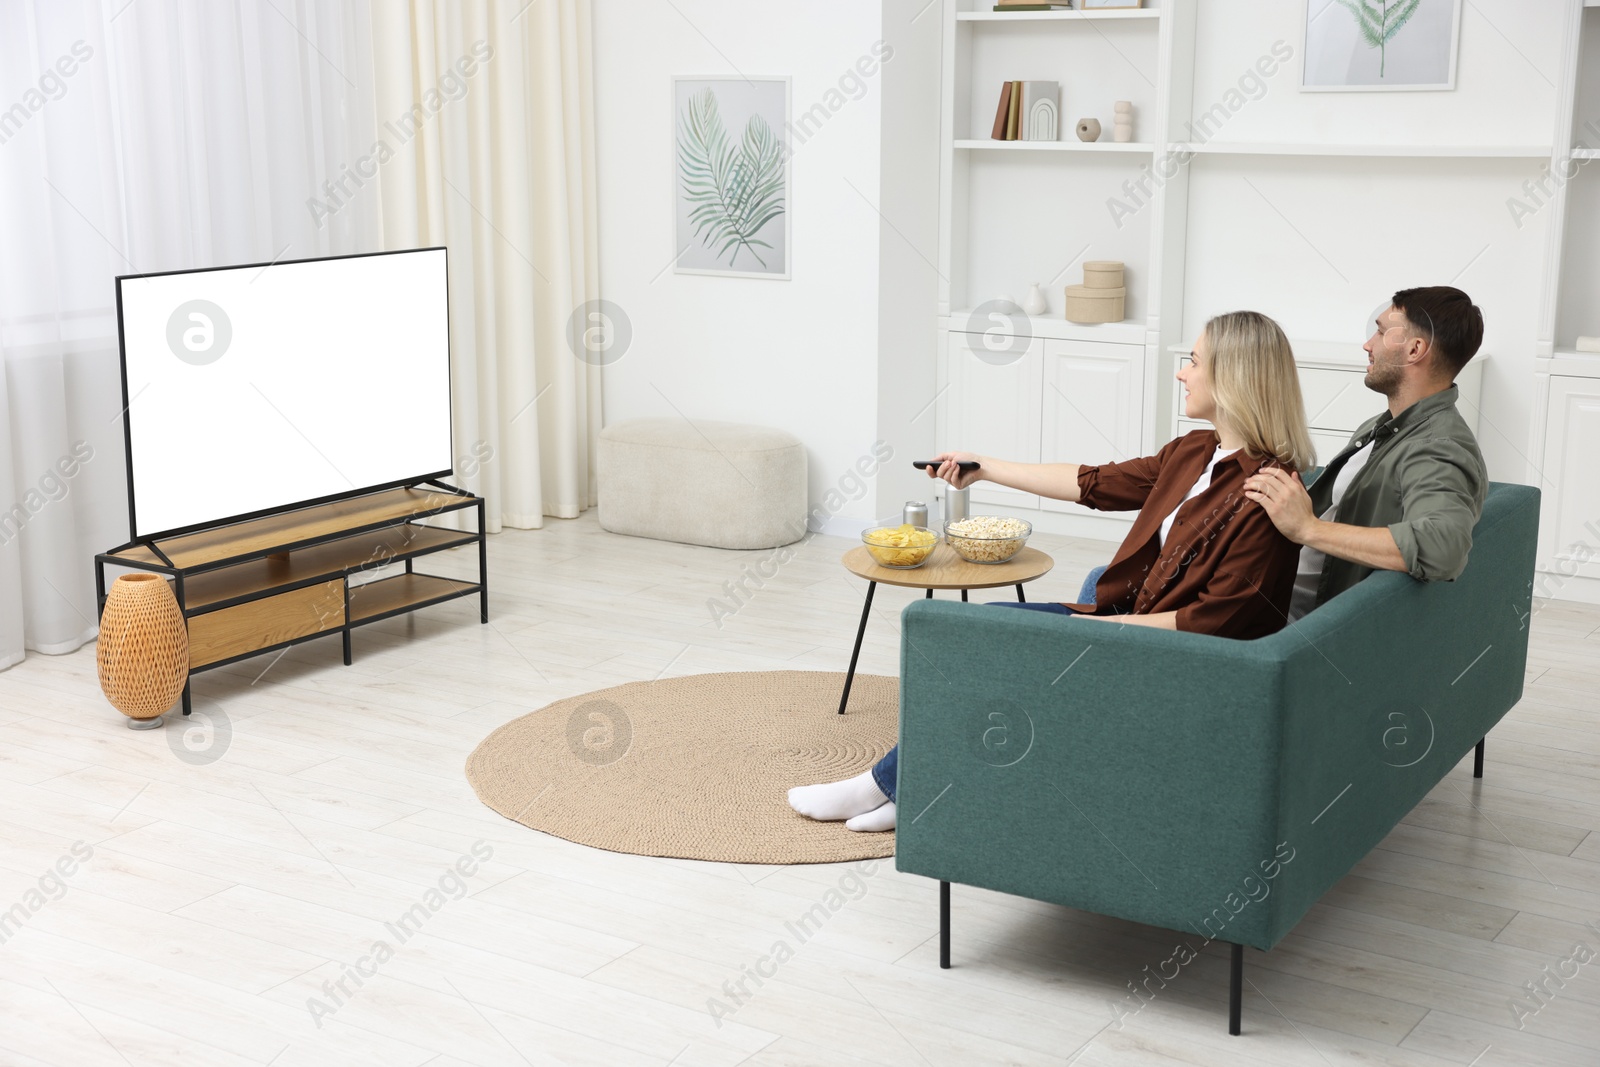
[934,0,1194,539]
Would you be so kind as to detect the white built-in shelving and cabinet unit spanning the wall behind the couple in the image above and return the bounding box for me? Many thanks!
[928,0,1600,585]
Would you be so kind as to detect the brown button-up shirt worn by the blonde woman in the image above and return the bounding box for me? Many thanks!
[1067,430,1299,638]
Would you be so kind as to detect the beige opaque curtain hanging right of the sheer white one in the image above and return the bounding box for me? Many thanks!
[368,0,600,531]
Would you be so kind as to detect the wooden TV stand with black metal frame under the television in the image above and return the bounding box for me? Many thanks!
[94,482,490,715]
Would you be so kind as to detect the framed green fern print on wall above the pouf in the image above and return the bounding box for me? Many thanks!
[672,75,794,280]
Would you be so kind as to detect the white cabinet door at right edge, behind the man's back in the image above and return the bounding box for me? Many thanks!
[1541,374,1600,577]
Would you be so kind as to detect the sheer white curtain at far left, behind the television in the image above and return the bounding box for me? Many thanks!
[0,0,378,665]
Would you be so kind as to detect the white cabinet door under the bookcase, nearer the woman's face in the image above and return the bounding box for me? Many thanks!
[1040,341,1144,512]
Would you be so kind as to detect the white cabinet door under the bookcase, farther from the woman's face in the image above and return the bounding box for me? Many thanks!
[939,333,1045,507]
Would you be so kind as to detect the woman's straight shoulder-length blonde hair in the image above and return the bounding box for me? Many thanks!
[1205,312,1317,470]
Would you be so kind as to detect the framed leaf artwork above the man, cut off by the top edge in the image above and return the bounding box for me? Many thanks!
[1301,0,1461,93]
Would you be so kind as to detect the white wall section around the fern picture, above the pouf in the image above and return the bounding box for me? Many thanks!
[594,0,908,533]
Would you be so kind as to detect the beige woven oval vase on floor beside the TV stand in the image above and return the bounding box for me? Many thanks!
[94,573,189,729]
